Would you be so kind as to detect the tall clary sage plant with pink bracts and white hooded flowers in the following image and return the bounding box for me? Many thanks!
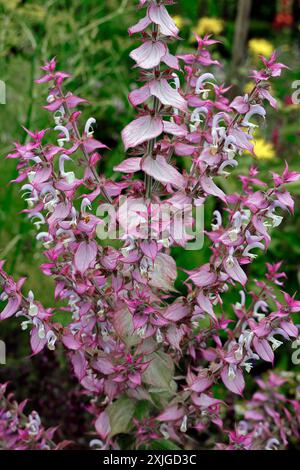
[0,0,300,449]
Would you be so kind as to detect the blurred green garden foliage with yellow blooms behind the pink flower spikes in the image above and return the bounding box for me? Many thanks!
[0,0,300,356]
